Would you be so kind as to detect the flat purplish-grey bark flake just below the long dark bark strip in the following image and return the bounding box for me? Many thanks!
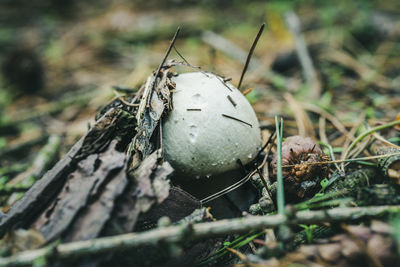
[33,141,125,241]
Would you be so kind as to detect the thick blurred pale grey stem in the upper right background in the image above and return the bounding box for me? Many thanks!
[285,11,321,99]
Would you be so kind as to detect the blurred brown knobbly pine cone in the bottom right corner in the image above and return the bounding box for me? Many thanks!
[284,221,400,266]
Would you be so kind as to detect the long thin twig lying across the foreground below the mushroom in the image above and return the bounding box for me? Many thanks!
[0,205,400,266]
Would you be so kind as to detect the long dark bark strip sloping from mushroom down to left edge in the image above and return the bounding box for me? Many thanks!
[0,108,134,240]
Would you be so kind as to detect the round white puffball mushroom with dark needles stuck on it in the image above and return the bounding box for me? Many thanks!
[162,72,261,179]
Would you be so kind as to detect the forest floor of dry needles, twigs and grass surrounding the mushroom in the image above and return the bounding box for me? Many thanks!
[0,0,400,266]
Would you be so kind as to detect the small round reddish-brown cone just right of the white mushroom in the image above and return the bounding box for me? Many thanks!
[271,135,328,198]
